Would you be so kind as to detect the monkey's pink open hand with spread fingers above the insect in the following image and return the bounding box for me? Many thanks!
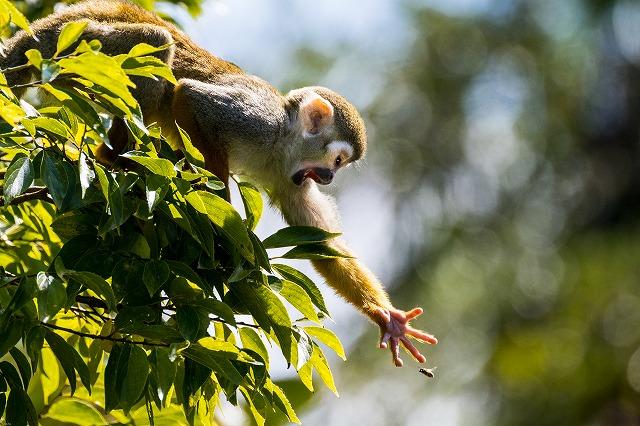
[375,308,438,367]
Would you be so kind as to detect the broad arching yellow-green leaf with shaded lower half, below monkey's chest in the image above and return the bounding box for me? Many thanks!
[185,191,253,262]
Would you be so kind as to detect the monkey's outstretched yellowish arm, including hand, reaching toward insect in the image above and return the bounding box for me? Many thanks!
[277,183,438,367]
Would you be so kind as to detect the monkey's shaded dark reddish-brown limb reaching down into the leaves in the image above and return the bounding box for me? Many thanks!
[171,81,229,198]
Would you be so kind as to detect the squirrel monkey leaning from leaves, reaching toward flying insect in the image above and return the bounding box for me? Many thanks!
[0,0,437,366]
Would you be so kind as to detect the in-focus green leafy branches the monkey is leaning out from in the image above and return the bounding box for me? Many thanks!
[0,7,344,425]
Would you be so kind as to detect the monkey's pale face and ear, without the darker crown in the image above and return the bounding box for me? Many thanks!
[291,92,354,185]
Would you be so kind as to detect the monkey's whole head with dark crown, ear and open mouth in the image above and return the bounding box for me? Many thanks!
[286,87,367,185]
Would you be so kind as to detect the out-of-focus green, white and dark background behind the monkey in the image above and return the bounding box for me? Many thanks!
[11,0,640,425]
